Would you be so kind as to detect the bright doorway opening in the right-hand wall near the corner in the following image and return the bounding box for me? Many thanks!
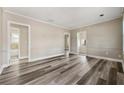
[77,31,87,55]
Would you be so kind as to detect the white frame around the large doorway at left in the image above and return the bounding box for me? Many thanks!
[7,21,31,65]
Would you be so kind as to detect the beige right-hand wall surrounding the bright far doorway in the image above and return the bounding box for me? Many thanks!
[70,18,122,59]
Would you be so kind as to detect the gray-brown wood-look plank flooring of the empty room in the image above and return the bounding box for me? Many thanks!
[0,55,124,85]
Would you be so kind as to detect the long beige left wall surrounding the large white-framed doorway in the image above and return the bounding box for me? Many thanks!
[3,12,67,64]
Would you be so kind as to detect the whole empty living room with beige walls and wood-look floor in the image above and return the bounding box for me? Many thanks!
[0,7,124,85]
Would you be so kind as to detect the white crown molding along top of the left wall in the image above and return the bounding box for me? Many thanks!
[4,9,69,30]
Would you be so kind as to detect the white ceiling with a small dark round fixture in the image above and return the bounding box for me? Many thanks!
[5,7,122,29]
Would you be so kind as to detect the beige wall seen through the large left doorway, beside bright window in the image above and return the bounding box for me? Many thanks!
[11,24,28,58]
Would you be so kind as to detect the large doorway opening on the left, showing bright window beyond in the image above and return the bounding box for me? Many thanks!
[8,22,30,64]
